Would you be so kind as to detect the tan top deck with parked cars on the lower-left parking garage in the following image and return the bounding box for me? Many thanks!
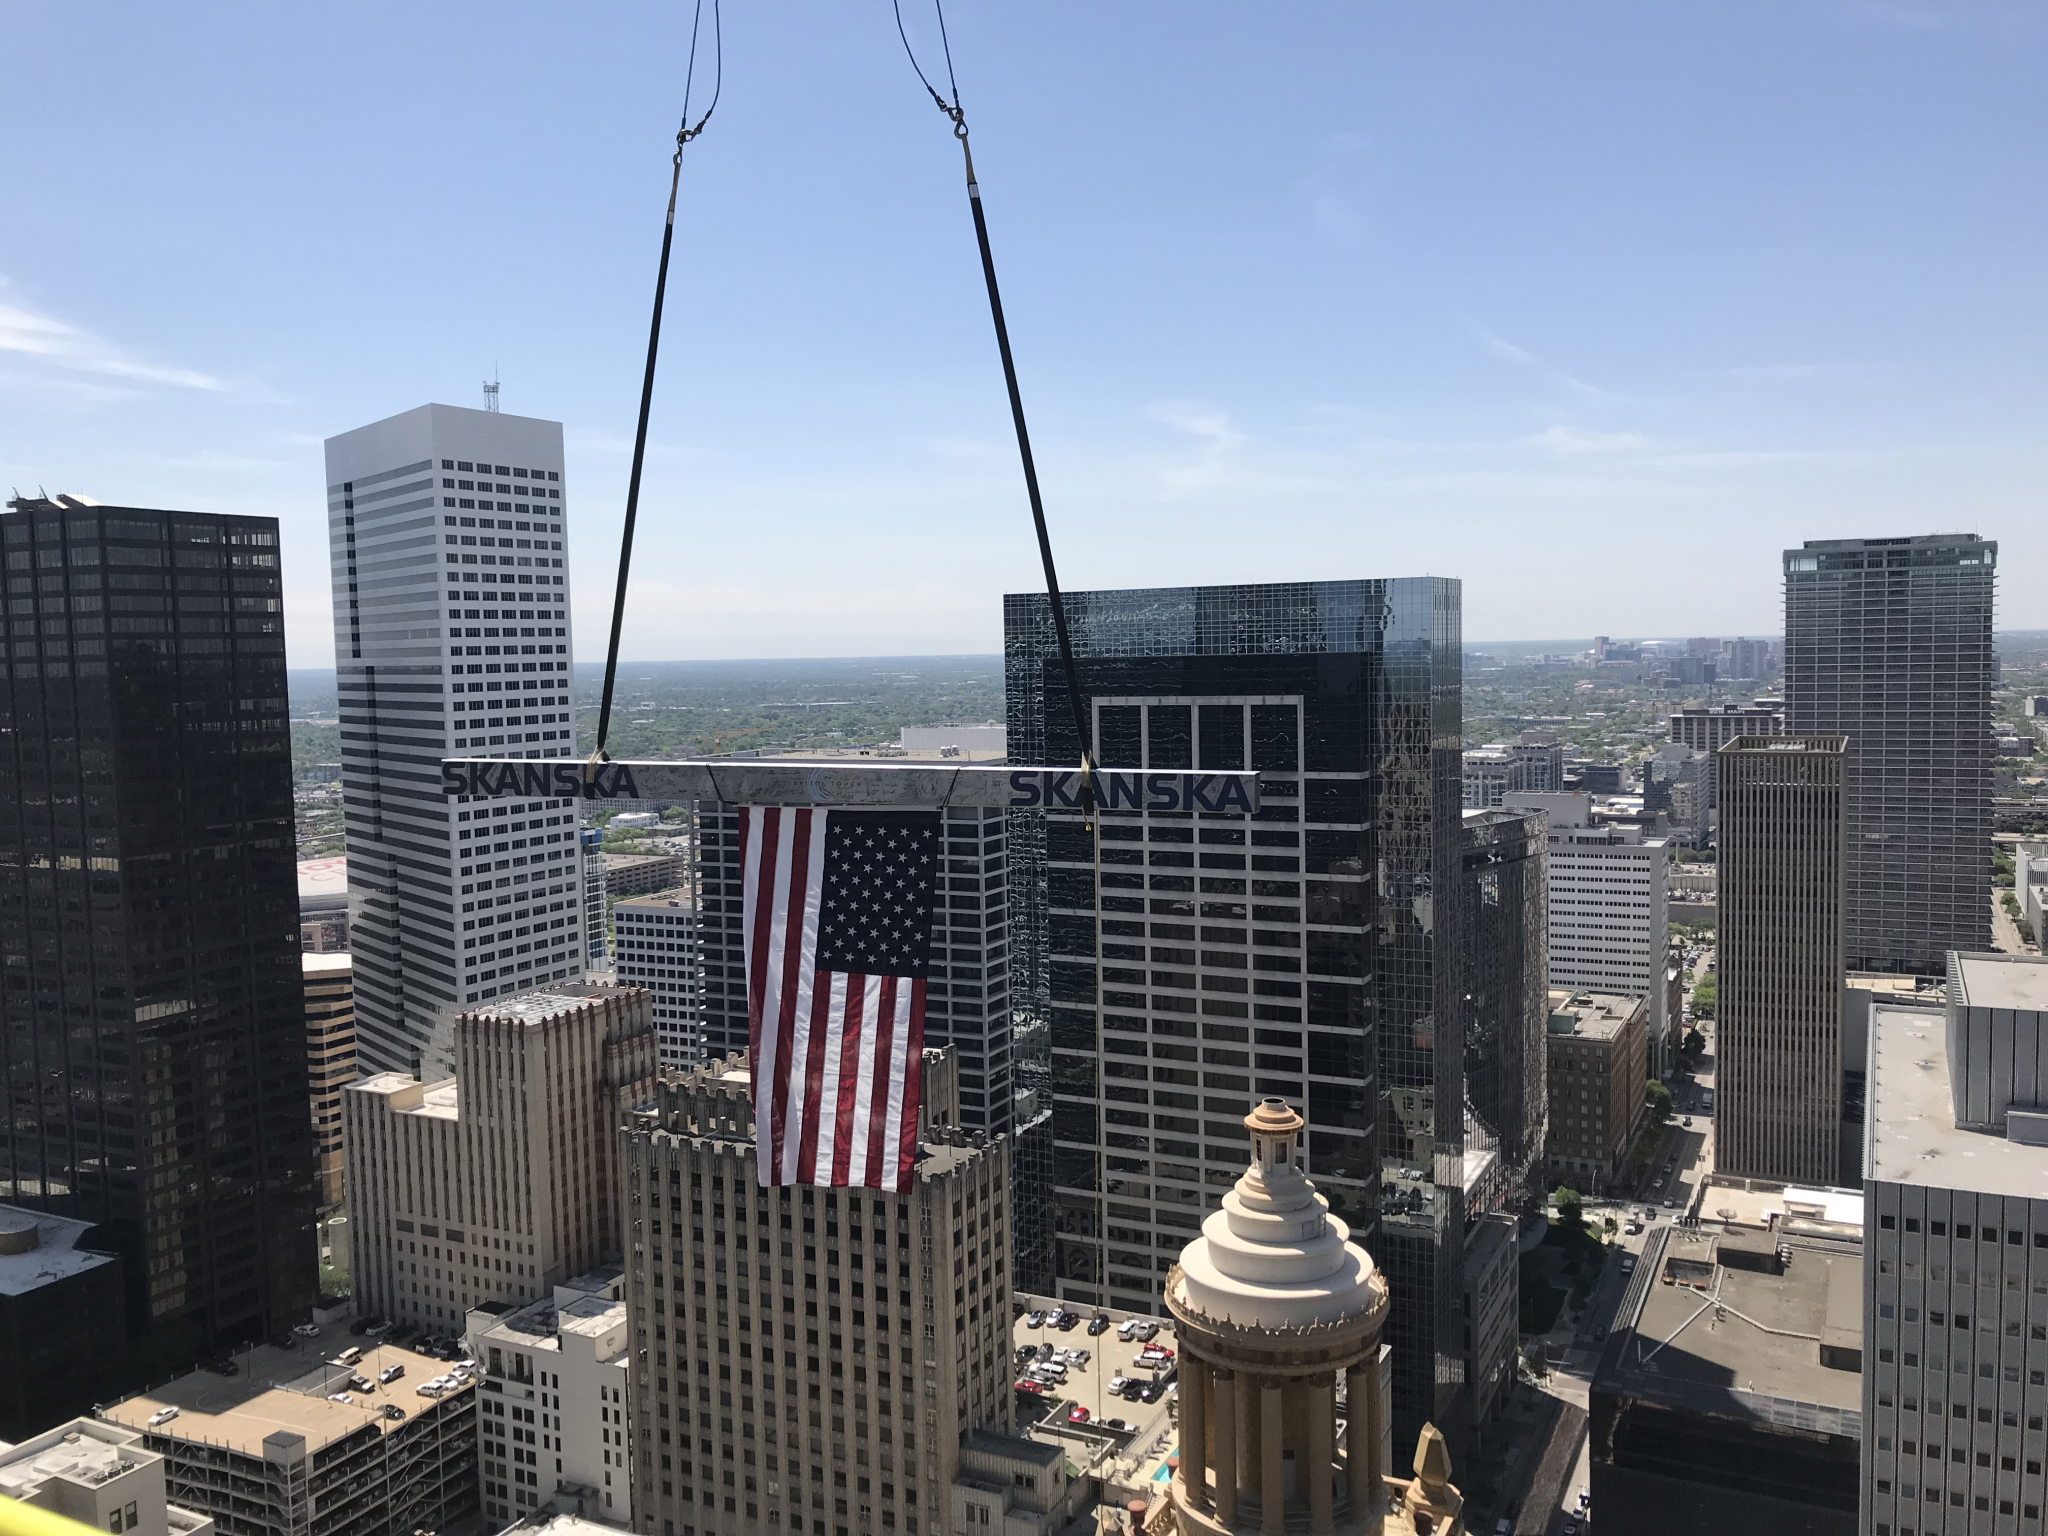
[100,1323,475,1458]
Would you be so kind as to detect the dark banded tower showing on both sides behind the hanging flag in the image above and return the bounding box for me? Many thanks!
[692,798,1016,1137]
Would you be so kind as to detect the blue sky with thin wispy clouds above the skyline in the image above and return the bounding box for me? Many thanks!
[0,0,2048,666]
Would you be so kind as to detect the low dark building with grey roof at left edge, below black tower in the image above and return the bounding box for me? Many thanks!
[0,1206,129,1440]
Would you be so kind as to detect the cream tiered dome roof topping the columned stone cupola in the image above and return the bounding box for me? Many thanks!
[1178,1098,1384,1327]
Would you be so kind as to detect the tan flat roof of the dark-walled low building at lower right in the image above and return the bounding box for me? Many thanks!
[1595,1229,1864,1432]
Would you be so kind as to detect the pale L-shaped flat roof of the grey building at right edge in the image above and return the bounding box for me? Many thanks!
[1866,997,2048,1200]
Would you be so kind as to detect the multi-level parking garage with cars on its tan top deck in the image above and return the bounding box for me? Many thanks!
[98,1325,477,1536]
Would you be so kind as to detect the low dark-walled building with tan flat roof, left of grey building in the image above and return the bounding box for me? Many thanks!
[1587,1227,1867,1536]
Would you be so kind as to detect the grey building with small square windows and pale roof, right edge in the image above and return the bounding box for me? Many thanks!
[1860,954,2048,1536]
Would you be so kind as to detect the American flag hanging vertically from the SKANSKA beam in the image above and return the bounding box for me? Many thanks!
[739,805,940,1190]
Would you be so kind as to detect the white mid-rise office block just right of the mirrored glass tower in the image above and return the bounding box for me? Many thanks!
[1503,795,1683,1077]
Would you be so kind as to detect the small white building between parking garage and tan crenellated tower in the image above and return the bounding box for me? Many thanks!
[465,1264,633,1530]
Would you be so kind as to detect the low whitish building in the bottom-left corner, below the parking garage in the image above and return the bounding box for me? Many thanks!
[0,1417,215,1536]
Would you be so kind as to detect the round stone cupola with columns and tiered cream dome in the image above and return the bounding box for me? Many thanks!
[1165,1098,1386,1536]
